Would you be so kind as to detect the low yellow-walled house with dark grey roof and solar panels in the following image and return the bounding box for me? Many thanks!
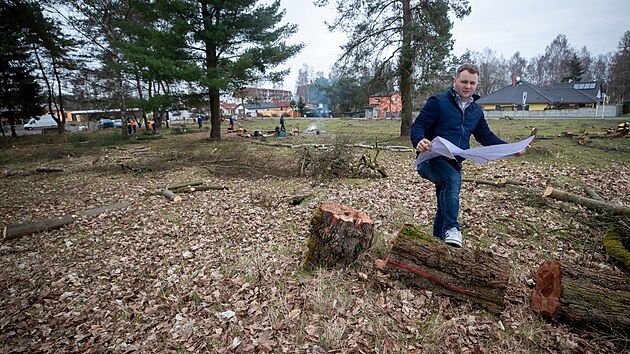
[477,80,601,111]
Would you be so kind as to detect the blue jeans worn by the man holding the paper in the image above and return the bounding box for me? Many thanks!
[418,156,462,240]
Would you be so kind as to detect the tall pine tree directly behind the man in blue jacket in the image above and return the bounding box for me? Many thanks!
[315,0,470,136]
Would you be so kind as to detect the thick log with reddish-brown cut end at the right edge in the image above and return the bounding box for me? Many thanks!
[531,261,630,336]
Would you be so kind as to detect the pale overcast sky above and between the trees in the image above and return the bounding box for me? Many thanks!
[270,0,630,92]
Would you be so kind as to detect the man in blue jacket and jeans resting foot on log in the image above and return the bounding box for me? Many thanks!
[410,64,506,247]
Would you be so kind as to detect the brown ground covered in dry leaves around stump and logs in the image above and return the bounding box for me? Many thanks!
[0,120,630,353]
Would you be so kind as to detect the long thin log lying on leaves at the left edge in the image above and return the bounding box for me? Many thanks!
[2,203,129,240]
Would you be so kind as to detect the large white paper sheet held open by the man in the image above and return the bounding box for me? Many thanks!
[416,135,535,167]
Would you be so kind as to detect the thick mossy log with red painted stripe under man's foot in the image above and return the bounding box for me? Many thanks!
[385,225,512,313]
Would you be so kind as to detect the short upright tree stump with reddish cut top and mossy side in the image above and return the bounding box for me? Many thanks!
[304,201,374,269]
